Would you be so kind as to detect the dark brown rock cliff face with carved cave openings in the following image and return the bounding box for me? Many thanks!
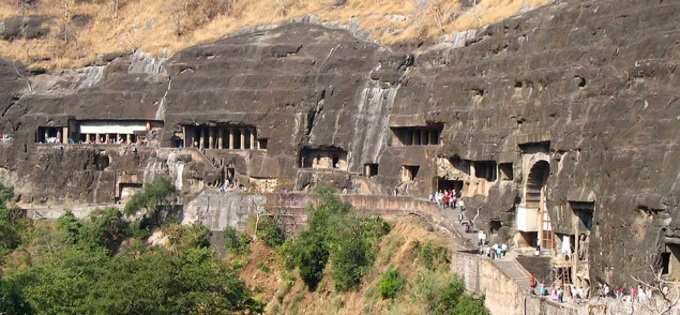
[0,0,680,284]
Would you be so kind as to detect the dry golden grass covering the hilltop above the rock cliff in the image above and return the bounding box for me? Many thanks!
[0,0,550,68]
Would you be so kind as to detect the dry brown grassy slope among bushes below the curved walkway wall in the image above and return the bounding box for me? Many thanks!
[241,218,451,315]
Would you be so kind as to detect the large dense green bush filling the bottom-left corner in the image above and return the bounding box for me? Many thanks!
[0,236,262,314]
